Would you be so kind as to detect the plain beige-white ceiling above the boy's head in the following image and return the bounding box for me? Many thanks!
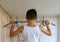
[0,0,60,18]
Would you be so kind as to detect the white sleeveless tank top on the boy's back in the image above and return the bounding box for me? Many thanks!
[22,25,41,42]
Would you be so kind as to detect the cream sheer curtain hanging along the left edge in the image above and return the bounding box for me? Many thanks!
[0,8,10,42]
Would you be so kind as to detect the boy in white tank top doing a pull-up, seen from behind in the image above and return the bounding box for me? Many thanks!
[10,9,51,42]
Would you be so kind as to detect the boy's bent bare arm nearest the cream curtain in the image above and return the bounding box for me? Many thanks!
[10,20,24,37]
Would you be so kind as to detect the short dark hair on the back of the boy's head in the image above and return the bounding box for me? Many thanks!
[26,9,37,20]
